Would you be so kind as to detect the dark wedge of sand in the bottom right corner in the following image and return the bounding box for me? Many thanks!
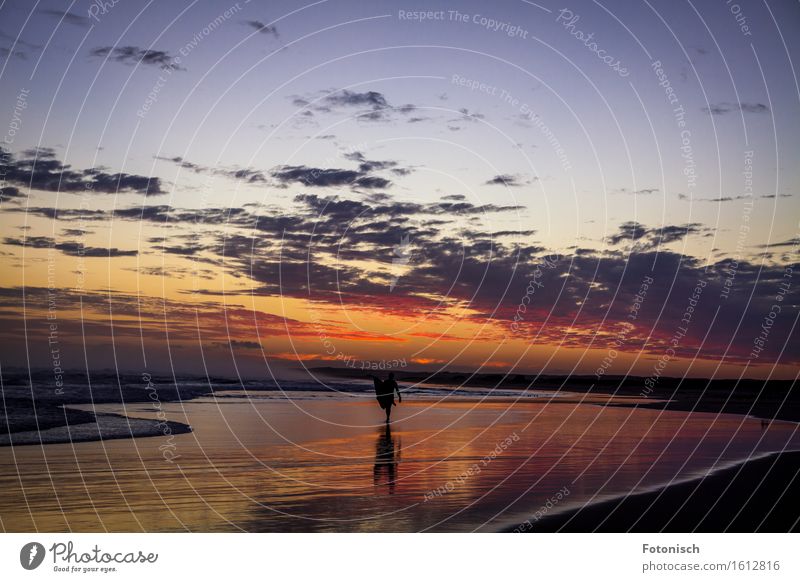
[501,451,800,533]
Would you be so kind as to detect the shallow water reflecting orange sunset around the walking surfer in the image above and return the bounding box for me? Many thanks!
[0,392,800,531]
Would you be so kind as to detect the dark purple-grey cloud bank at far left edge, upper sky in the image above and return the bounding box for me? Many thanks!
[0,147,164,196]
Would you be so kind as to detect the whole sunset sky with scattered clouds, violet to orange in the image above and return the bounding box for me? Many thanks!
[0,0,800,378]
